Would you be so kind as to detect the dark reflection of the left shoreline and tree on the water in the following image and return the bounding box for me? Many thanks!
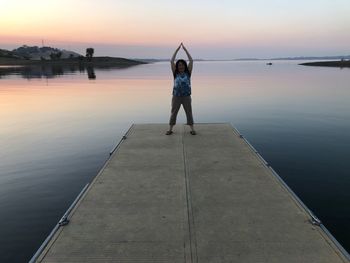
[0,64,137,80]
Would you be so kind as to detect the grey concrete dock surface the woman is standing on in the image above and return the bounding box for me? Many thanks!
[37,124,349,263]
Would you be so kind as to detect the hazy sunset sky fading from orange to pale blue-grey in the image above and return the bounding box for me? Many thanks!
[0,0,350,59]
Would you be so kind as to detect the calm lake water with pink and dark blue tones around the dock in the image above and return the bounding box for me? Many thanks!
[0,61,350,262]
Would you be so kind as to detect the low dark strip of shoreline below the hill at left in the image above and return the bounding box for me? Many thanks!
[0,57,148,67]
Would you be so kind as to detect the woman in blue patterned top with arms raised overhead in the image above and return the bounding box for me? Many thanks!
[166,43,196,135]
